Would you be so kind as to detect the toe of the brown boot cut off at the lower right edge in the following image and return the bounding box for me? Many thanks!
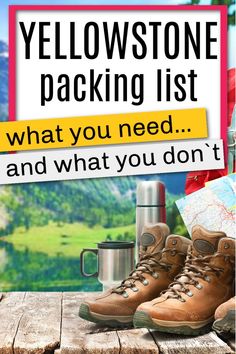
[212,296,236,334]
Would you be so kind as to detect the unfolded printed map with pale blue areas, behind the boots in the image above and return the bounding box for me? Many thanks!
[176,173,236,238]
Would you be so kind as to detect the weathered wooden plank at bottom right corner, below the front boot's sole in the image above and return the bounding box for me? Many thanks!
[152,331,233,354]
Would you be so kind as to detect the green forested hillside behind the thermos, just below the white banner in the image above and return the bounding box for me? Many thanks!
[0,175,188,235]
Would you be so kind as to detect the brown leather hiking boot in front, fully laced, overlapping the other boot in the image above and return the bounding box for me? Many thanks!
[134,225,235,335]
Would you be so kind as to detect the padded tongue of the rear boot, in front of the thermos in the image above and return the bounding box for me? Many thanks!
[140,223,170,255]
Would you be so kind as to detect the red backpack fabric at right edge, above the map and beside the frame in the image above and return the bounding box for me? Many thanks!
[185,68,236,194]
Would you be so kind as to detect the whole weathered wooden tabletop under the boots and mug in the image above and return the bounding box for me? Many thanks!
[0,293,234,354]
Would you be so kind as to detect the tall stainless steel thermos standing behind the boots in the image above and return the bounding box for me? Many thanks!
[136,181,166,259]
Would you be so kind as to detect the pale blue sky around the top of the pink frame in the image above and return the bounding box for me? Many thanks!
[0,0,236,67]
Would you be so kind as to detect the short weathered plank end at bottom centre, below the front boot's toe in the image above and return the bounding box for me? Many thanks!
[117,328,159,354]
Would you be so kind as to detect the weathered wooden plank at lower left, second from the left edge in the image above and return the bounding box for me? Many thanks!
[14,293,62,354]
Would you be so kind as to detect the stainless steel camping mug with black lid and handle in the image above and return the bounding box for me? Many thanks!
[80,241,135,290]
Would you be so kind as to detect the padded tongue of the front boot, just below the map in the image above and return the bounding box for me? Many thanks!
[192,225,226,256]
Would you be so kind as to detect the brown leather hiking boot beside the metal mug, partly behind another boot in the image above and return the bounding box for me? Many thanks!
[79,223,191,327]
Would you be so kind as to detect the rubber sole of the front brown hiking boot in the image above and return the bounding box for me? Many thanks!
[133,311,212,336]
